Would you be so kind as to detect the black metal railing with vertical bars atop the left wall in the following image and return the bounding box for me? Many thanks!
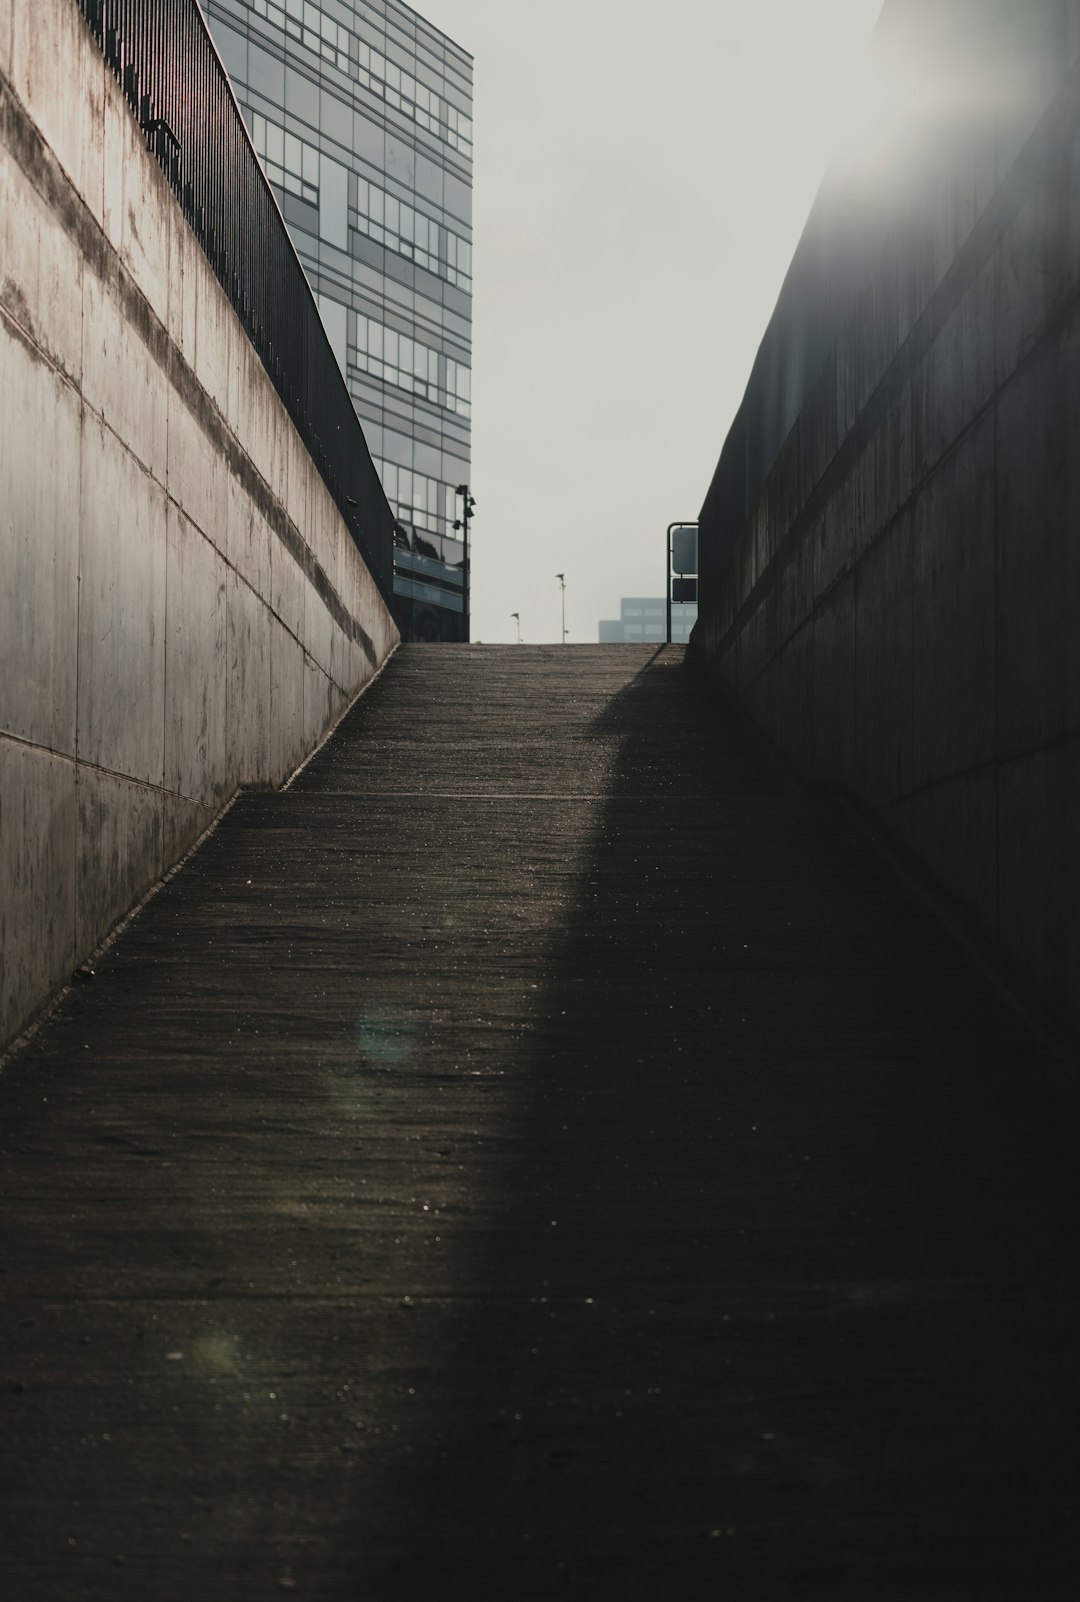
[77,0,394,604]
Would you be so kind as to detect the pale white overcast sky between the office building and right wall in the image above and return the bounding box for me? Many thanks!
[417,0,881,642]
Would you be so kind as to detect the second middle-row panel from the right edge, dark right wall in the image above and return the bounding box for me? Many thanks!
[912,413,997,785]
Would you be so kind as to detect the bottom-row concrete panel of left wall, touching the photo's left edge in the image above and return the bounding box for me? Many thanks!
[0,735,75,1041]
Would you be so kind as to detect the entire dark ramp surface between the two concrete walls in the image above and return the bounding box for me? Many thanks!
[0,646,1080,1602]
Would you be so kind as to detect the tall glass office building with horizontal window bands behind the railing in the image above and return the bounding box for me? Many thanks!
[204,0,473,639]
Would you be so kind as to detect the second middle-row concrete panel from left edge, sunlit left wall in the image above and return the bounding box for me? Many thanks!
[79,415,165,785]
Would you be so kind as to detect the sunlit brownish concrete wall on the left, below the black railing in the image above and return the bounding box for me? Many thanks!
[0,0,397,1048]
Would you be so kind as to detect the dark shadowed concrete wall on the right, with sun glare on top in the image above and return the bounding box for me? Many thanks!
[692,0,1080,1027]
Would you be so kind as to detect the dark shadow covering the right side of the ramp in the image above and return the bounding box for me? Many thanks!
[363,655,1078,1602]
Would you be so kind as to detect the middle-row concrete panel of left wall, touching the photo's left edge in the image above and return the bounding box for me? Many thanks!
[0,317,80,756]
